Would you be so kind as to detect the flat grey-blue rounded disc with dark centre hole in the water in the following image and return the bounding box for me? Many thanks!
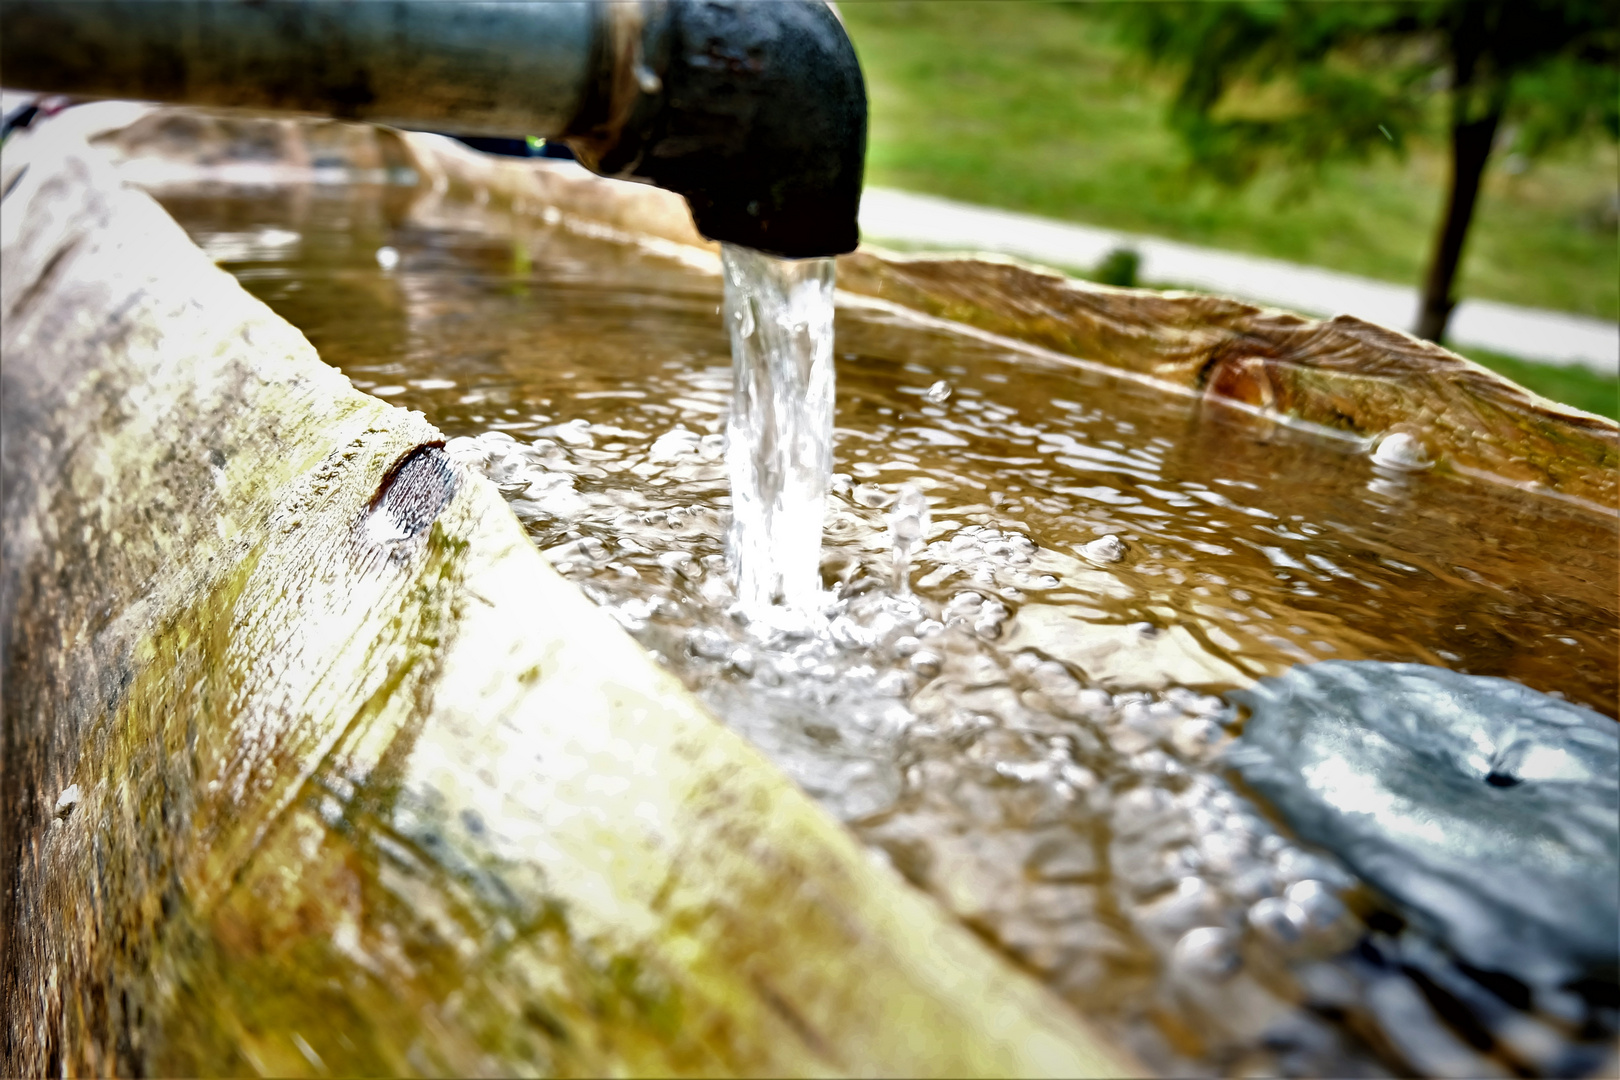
[1228,661,1620,984]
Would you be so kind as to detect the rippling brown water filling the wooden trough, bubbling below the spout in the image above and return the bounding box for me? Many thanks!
[167,181,1620,1077]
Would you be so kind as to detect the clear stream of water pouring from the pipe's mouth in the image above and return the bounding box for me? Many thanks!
[721,244,834,630]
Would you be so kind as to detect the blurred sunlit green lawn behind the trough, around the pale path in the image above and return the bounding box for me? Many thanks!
[839,0,1620,418]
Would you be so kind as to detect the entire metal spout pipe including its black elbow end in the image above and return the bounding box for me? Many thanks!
[0,0,867,257]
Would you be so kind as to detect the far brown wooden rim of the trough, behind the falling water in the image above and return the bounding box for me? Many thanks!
[358,122,1620,513]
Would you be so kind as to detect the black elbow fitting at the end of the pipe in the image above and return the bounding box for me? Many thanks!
[562,0,867,259]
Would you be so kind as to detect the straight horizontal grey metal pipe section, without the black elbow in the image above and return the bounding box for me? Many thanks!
[0,0,608,134]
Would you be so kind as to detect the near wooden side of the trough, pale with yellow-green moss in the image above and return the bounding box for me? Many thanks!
[0,123,1132,1075]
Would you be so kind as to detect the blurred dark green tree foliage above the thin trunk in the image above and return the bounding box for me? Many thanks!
[1105,0,1620,183]
